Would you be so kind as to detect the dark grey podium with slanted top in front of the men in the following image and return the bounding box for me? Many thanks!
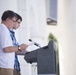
[24,40,56,75]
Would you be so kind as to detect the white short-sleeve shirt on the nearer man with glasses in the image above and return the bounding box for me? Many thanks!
[0,24,15,69]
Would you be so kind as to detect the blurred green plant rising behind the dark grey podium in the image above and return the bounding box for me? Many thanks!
[48,33,60,75]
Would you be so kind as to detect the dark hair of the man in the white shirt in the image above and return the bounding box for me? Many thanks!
[1,10,17,21]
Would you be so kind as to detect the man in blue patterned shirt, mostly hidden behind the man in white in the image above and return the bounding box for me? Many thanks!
[10,13,25,75]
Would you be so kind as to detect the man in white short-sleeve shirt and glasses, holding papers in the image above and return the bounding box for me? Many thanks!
[0,10,28,75]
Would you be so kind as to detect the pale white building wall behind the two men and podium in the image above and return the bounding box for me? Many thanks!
[0,0,76,75]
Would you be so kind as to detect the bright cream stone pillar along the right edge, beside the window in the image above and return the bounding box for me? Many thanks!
[58,0,76,75]
